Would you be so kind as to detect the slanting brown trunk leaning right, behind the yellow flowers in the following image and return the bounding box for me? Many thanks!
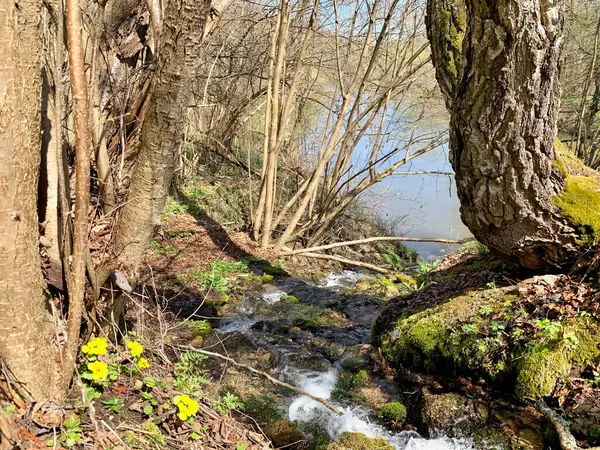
[115,0,210,267]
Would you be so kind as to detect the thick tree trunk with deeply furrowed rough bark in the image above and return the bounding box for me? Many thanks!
[427,0,595,270]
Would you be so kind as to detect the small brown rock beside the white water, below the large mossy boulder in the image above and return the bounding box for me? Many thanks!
[422,389,488,432]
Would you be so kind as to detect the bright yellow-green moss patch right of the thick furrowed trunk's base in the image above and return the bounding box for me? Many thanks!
[554,175,600,241]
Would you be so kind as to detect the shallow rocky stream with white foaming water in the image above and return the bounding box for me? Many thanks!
[218,271,482,450]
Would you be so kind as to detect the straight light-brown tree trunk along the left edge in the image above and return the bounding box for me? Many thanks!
[0,0,60,399]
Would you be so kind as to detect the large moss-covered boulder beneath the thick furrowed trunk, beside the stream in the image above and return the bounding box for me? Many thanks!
[374,280,600,402]
